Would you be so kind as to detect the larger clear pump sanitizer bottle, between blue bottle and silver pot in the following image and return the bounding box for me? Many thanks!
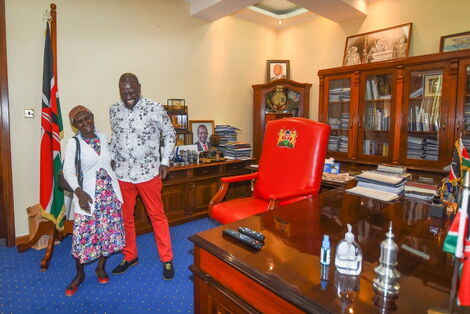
[335,224,362,276]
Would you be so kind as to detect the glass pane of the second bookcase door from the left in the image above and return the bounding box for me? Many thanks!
[359,73,393,160]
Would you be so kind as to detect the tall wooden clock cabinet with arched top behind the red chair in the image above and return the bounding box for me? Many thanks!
[252,79,312,160]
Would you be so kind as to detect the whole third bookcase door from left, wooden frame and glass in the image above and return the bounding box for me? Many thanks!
[401,62,456,169]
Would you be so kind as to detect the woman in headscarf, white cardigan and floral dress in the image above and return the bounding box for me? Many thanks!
[64,106,125,296]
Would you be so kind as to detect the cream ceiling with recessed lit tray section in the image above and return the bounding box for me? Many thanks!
[186,0,370,29]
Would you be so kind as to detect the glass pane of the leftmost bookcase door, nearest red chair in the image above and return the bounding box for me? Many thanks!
[327,78,351,154]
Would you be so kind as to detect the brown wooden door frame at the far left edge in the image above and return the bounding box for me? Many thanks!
[0,0,15,246]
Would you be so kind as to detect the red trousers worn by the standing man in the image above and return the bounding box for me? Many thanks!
[119,176,173,262]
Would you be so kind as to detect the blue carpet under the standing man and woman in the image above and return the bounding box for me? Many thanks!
[0,218,217,313]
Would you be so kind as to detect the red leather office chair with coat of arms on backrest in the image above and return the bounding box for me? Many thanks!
[209,118,330,224]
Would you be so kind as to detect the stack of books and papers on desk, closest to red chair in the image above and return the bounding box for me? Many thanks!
[348,165,410,200]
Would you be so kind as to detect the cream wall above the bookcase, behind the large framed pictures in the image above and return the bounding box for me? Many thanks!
[278,0,470,120]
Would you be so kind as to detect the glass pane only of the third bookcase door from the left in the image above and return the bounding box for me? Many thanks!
[405,69,444,161]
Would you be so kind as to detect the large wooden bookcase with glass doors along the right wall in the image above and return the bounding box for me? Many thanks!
[318,50,470,172]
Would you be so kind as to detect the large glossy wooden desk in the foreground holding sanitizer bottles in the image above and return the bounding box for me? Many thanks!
[190,190,458,313]
